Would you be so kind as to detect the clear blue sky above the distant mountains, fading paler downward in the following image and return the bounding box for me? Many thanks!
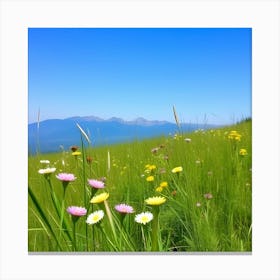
[28,28,252,124]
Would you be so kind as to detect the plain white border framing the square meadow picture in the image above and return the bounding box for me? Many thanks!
[0,0,280,280]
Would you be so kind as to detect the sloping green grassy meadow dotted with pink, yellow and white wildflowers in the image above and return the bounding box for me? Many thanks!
[28,120,252,252]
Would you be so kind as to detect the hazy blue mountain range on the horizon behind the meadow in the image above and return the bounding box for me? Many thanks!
[28,116,221,154]
